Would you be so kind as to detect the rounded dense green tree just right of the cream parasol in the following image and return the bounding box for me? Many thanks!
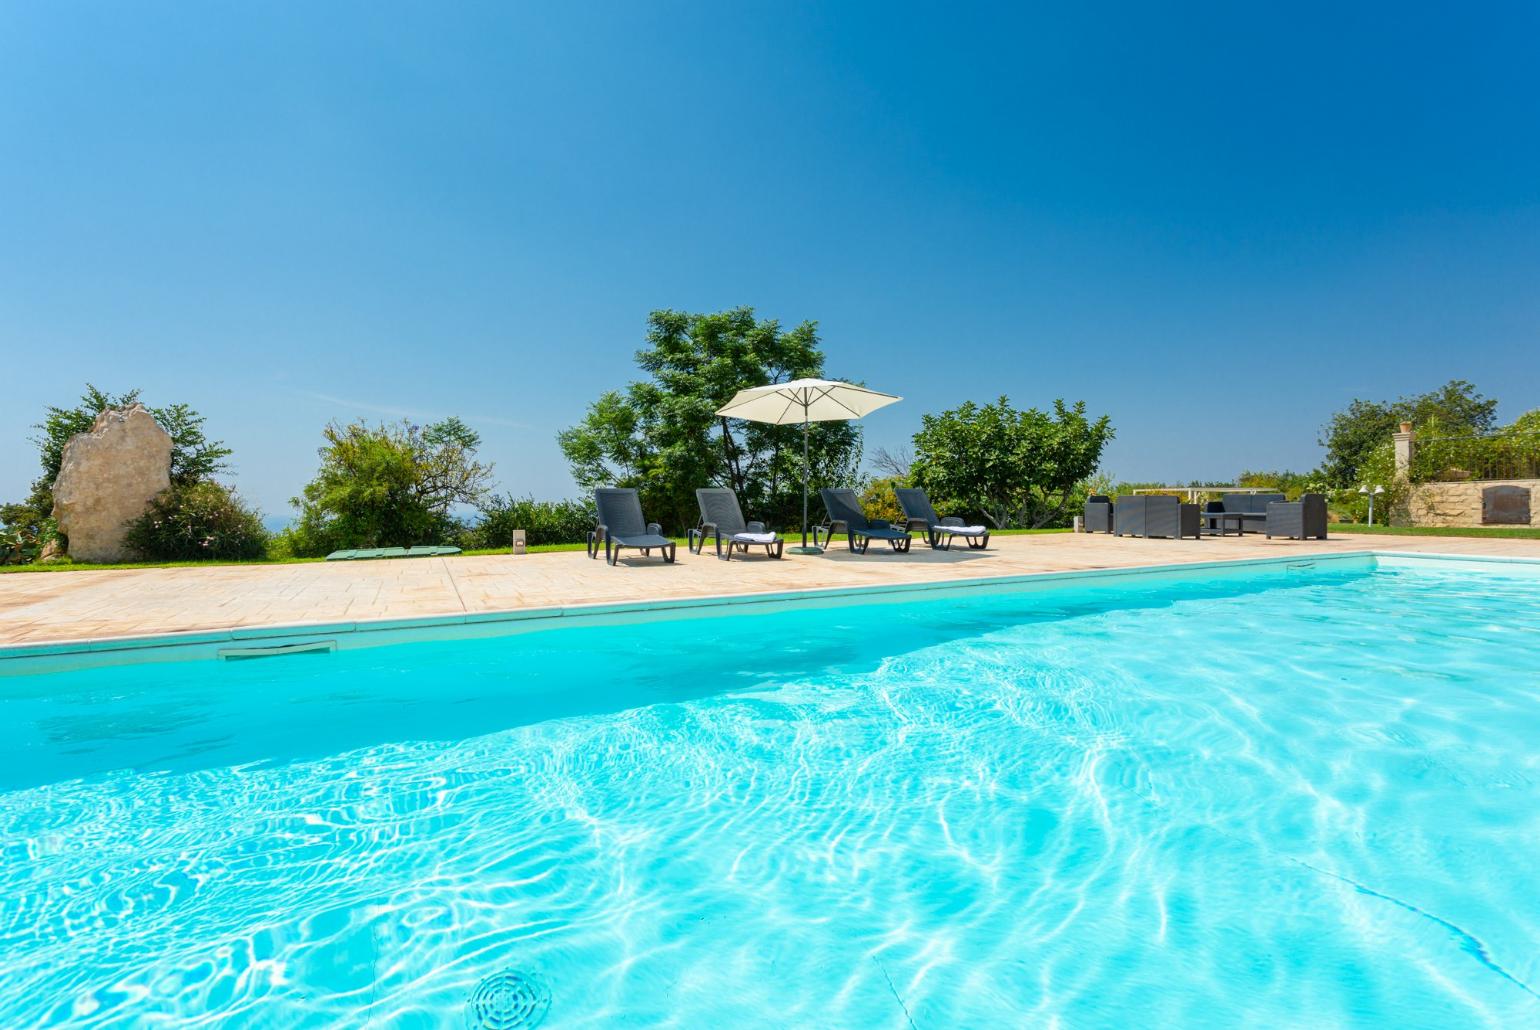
[912,397,1113,528]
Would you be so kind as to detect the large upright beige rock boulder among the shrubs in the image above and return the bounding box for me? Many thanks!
[54,405,171,562]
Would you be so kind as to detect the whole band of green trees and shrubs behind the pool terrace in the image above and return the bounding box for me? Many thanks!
[0,308,1540,568]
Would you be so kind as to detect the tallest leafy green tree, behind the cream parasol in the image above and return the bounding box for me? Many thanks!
[557,308,861,531]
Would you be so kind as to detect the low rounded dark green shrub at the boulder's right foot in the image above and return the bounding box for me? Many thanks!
[126,482,268,562]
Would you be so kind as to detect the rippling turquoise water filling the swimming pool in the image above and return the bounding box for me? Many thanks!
[0,562,1540,1027]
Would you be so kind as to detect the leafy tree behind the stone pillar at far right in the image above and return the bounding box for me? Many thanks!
[1320,379,1497,488]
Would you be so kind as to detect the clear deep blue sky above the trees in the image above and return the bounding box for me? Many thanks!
[0,0,1540,514]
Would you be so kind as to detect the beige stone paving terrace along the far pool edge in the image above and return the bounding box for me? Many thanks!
[0,534,1540,645]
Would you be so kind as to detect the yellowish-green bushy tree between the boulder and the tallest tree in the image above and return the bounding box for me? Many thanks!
[283,419,491,556]
